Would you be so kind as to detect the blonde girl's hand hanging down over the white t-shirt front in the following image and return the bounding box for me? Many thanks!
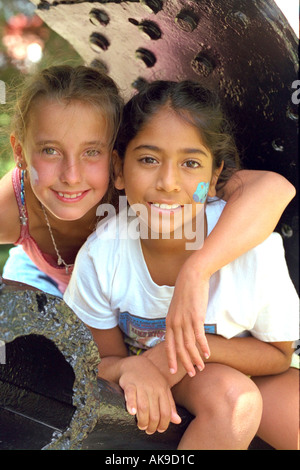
[165,264,210,377]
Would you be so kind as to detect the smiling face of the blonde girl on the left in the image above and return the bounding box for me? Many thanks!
[13,99,110,220]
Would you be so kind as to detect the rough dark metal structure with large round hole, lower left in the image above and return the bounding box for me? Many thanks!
[0,281,191,450]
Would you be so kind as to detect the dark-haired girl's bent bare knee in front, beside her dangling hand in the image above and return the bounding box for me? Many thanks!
[172,364,262,450]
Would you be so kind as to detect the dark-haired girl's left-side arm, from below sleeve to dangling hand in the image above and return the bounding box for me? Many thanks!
[90,327,181,434]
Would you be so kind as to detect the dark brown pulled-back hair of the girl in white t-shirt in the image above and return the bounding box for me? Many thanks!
[116,80,240,190]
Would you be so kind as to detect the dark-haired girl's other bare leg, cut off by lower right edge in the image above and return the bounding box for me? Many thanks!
[253,368,299,450]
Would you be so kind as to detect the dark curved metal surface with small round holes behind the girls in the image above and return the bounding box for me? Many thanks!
[28,0,299,289]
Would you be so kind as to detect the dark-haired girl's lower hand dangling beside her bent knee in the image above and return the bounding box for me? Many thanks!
[119,356,181,434]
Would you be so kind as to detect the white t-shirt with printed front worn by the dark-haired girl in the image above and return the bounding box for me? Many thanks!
[64,200,299,348]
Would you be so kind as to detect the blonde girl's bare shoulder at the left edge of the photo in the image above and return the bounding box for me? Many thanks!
[0,171,20,244]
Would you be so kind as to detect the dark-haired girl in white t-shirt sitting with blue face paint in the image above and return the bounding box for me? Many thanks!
[65,82,298,449]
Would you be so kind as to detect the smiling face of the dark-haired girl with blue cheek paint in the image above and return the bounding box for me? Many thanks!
[116,107,222,237]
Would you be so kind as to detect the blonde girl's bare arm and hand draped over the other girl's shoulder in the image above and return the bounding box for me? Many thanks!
[165,170,295,374]
